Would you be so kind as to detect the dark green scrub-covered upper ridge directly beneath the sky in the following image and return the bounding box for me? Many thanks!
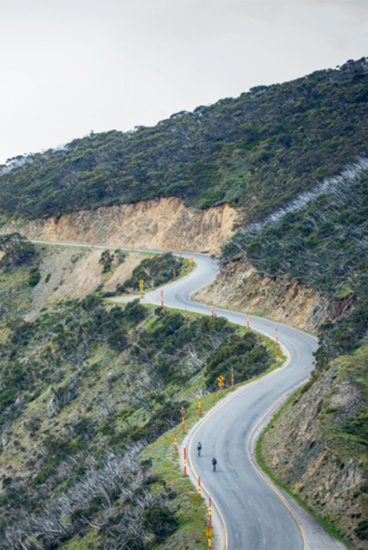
[0,58,368,220]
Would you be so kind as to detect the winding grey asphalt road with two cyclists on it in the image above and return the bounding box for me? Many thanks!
[33,243,346,550]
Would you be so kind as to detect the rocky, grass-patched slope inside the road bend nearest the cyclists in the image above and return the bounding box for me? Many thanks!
[259,345,368,549]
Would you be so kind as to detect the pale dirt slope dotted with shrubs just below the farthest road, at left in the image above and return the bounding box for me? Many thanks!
[0,238,189,328]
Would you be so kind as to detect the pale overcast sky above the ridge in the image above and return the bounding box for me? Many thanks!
[0,0,368,163]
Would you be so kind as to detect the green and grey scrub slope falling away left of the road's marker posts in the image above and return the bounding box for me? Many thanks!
[0,249,274,550]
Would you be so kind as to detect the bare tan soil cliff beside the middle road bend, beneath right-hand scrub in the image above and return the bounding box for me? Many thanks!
[196,260,354,334]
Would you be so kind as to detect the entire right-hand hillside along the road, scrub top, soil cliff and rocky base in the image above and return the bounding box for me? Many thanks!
[207,166,368,548]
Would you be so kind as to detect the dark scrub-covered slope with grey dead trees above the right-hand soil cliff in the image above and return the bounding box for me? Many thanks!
[223,169,368,365]
